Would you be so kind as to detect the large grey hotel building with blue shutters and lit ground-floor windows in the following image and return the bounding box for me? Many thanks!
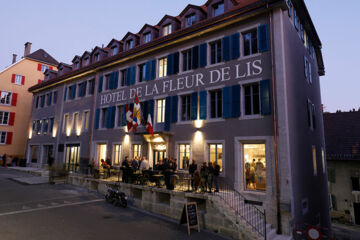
[27,0,330,234]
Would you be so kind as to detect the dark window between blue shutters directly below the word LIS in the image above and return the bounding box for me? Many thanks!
[244,83,260,115]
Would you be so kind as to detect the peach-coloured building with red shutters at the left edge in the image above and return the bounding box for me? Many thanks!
[0,42,58,158]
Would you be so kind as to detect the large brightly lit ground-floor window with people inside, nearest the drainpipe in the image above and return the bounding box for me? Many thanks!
[243,144,266,191]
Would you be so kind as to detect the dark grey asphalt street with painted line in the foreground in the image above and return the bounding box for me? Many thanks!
[0,167,227,240]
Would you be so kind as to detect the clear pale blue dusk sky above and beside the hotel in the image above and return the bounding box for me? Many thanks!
[0,0,360,112]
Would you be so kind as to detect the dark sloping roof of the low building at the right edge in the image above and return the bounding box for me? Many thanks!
[323,111,360,160]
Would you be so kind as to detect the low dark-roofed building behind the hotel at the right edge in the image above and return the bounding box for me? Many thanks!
[324,111,360,224]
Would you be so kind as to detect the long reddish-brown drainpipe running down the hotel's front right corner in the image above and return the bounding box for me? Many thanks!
[267,3,282,234]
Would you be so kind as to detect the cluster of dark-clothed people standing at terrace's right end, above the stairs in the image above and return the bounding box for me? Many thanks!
[189,160,220,192]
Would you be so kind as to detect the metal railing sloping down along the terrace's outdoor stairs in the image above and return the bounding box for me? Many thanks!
[215,178,266,239]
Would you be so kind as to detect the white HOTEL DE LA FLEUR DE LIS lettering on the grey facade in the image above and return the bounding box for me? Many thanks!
[100,59,263,105]
